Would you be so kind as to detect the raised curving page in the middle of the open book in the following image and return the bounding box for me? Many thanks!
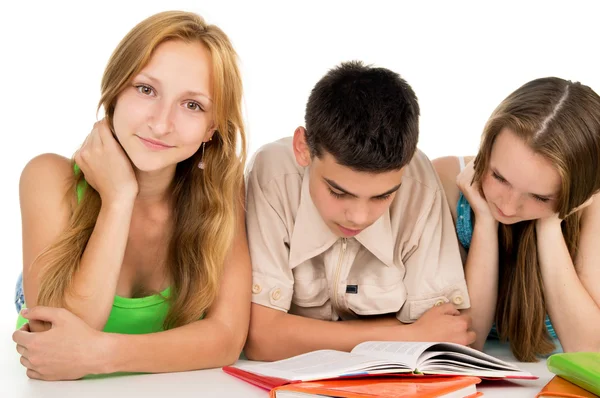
[352,341,436,370]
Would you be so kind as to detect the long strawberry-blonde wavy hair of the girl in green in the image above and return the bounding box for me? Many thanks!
[36,11,246,328]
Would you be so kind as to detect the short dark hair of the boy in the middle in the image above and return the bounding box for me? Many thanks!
[305,61,419,173]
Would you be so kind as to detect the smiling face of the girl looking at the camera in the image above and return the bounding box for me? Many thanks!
[113,40,214,171]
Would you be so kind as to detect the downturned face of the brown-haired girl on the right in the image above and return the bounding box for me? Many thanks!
[481,129,561,224]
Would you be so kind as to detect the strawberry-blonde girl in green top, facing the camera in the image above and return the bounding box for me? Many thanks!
[13,11,251,380]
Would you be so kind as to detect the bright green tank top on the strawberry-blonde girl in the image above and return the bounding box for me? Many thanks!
[17,165,171,334]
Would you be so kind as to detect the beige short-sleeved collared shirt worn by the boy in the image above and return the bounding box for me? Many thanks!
[246,138,470,323]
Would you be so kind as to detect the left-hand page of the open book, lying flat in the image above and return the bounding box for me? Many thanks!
[239,350,396,381]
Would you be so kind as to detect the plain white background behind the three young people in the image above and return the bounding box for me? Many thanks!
[0,0,600,346]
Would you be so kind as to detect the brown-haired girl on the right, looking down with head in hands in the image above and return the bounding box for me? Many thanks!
[434,77,600,361]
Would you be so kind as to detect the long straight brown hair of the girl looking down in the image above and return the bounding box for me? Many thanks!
[474,77,600,361]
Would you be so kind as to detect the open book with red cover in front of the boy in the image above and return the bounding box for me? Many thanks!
[223,341,537,390]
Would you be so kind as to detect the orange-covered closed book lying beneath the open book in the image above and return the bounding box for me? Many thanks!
[269,376,483,398]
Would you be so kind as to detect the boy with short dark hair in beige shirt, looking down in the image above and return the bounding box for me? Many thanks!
[245,62,474,361]
